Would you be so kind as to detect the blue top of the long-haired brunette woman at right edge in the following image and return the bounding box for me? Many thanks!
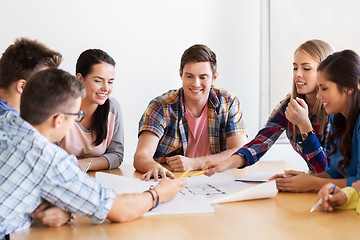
[325,115,360,186]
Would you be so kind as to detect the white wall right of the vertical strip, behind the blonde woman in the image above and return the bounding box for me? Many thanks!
[270,0,360,107]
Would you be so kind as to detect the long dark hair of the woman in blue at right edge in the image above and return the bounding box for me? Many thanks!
[317,50,360,174]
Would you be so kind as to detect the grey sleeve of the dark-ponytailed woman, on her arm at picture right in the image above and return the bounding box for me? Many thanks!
[103,98,124,169]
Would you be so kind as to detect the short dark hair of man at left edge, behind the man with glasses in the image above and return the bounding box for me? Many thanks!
[0,38,62,89]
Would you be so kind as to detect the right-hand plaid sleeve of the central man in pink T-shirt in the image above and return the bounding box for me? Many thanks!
[225,97,245,137]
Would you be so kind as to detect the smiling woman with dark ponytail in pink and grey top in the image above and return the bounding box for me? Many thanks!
[60,49,124,170]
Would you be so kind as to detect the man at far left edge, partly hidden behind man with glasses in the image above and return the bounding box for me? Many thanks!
[0,38,62,115]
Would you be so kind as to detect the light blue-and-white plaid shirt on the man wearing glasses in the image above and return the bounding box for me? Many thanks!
[0,111,115,236]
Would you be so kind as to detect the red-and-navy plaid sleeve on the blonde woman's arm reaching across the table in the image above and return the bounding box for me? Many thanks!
[235,99,287,166]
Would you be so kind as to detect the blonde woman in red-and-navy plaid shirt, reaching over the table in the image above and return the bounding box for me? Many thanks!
[205,40,334,175]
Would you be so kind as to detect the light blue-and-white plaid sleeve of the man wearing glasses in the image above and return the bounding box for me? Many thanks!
[40,151,115,223]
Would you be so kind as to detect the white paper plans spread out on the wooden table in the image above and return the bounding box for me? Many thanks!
[95,172,277,215]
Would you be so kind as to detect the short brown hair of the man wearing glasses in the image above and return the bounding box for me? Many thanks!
[20,69,85,125]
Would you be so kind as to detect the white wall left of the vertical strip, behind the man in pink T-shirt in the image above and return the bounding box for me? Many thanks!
[0,0,260,163]
